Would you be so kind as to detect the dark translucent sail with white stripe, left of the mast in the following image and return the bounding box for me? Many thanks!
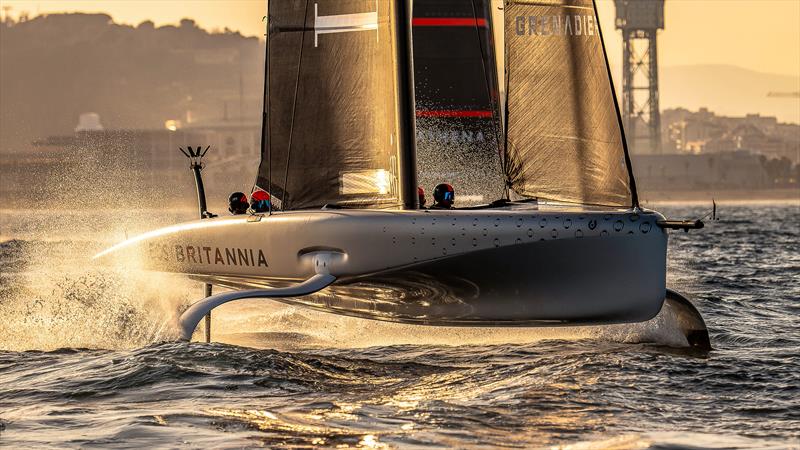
[256,0,401,209]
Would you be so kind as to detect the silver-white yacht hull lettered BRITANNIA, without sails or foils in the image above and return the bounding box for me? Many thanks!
[98,207,667,326]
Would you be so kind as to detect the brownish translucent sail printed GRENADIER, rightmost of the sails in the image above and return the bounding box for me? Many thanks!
[504,0,634,207]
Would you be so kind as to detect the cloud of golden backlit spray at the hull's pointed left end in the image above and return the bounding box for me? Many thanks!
[0,213,197,351]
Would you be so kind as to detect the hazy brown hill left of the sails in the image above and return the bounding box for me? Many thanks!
[0,14,264,152]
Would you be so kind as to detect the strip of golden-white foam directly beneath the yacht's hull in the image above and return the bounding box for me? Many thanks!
[212,300,687,348]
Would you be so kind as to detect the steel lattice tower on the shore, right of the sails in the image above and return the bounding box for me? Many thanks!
[614,0,664,153]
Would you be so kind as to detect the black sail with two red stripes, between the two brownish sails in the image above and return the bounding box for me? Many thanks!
[413,0,503,206]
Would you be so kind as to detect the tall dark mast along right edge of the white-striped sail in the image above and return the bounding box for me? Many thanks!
[393,0,419,209]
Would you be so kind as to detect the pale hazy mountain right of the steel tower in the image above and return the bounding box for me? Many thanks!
[659,65,800,123]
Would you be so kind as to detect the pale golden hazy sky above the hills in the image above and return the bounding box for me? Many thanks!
[0,0,800,75]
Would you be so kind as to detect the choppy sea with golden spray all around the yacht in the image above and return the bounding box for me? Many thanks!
[0,202,800,449]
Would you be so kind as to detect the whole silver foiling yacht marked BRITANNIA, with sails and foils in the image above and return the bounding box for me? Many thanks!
[90,0,708,347]
